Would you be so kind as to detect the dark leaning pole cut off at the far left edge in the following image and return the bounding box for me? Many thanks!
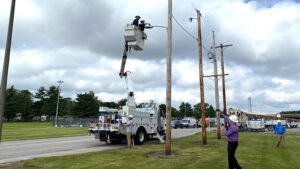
[0,0,16,143]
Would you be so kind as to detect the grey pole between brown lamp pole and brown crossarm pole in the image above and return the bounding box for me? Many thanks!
[212,31,221,139]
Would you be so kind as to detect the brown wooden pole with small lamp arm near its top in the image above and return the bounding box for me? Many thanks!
[197,10,207,145]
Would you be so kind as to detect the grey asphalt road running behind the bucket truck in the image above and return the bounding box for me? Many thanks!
[0,128,201,163]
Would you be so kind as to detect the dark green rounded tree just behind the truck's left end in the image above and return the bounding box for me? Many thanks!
[74,91,99,117]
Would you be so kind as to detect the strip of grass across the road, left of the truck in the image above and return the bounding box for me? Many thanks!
[2,122,88,141]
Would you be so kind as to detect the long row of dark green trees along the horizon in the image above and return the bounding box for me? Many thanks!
[4,86,216,121]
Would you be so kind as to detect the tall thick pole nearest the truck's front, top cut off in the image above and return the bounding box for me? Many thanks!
[165,0,172,155]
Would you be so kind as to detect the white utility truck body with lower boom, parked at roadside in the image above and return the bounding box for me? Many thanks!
[89,71,166,144]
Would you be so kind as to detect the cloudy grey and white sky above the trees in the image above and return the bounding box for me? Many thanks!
[0,0,300,113]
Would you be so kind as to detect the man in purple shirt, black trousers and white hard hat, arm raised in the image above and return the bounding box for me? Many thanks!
[221,112,242,169]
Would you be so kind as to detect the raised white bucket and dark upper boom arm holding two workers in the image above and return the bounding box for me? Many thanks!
[119,24,147,78]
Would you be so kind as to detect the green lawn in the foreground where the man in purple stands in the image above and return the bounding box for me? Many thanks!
[20,132,300,169]
